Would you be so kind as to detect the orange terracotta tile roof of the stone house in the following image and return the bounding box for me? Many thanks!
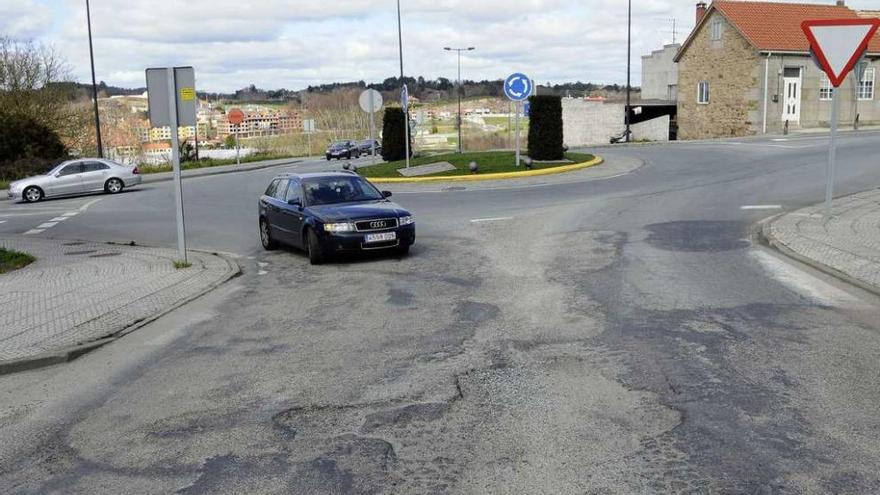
[679,0,880,56]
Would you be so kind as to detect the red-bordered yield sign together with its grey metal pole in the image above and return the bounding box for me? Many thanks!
[801,18,880,222]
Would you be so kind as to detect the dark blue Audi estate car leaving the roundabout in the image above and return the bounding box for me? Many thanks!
[259,172,416,265]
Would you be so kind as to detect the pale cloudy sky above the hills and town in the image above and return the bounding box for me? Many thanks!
[0,0,880,91]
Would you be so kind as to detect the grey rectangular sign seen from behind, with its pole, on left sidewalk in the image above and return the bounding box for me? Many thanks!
[147,67,198,263]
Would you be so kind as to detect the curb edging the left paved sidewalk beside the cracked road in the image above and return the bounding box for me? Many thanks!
[0,251,241,376]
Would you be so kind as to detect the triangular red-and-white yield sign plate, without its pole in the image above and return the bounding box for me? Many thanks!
[801,19,880,88]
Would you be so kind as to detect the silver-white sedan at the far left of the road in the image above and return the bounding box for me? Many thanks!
[9,158,143,203]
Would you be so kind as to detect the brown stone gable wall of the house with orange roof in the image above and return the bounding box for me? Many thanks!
[678,12,763,139]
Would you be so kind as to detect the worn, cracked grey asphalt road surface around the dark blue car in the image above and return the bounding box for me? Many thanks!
[0,133,880,494]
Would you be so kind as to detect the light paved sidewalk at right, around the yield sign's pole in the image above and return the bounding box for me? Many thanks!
[763,189,880,294]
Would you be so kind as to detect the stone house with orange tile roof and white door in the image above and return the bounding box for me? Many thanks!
[675,0,880,139]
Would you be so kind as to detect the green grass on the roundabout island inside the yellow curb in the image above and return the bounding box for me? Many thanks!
[358,151,594,181]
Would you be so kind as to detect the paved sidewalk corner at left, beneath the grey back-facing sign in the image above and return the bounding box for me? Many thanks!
[0,237,239,374]
